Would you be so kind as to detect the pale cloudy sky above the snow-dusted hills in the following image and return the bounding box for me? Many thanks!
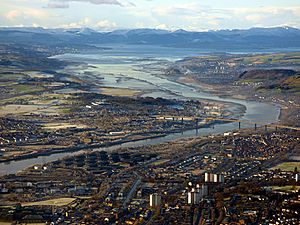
[0,0,300,31]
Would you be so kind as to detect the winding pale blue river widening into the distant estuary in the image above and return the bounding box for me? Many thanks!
[0,45,280,175]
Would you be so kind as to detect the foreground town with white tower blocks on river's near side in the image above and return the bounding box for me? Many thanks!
[0,129,300,224]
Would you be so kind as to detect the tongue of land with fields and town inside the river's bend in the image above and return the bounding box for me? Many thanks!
[0,50,237,162]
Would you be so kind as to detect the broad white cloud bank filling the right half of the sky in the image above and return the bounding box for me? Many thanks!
[152,1,300,31]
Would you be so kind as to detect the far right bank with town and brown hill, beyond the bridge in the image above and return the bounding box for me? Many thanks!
[163,52,300,125]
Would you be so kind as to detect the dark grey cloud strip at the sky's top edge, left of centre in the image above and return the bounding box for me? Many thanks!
[47,0,134,9]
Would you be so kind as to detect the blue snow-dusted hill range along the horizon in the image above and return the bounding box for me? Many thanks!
[0,27,300,50]
